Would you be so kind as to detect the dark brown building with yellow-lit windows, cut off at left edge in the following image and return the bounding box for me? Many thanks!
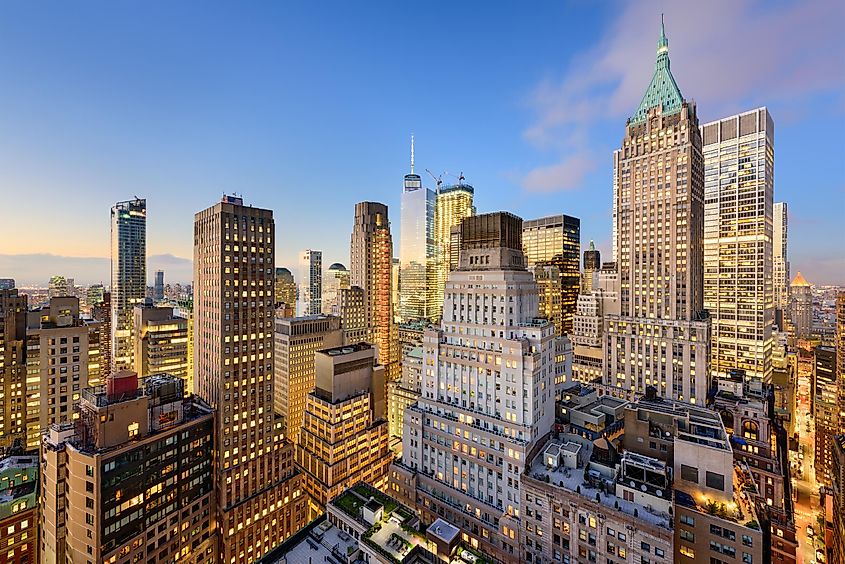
[0,289,27,451]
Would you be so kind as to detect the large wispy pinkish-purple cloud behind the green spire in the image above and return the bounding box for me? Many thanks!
[523,0,845,189]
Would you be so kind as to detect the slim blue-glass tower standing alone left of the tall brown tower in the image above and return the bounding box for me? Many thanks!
[111,199,147,370]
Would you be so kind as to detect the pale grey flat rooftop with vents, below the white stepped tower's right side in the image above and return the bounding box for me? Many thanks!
[526,440,672,529]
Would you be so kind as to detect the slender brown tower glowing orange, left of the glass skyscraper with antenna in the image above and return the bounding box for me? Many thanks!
[350,202,399,382]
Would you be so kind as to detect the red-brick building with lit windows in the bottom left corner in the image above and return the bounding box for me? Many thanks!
[0,449,40,564]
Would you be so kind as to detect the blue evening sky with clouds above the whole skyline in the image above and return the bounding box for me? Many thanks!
[0,0,845,285]
